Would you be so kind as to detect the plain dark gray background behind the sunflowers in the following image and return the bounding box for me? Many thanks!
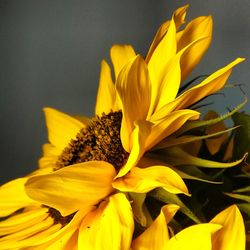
[0,0,250,183]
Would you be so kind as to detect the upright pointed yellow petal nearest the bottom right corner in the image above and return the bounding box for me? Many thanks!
[210,205,246,250]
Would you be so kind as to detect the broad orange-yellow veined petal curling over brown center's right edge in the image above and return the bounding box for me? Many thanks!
[116,56,151,152]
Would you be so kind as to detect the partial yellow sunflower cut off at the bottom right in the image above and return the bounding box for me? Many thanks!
[131,205,246,250]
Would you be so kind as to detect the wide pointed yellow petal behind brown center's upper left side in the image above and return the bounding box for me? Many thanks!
[44,108,84,150]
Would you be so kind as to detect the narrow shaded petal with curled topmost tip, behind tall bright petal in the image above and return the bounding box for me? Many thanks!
[145,5,188,63]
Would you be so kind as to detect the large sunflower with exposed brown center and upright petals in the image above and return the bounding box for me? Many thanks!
[0,6,246,249]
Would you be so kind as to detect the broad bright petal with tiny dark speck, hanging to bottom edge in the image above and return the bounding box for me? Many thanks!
[78,193,134,250]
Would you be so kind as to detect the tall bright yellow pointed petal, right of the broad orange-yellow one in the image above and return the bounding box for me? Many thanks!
[148,18,177,114]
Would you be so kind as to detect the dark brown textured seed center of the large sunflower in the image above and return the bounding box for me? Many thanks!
[54,111,129,170]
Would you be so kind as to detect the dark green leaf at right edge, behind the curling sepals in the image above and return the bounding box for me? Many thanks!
[232,112,250,162]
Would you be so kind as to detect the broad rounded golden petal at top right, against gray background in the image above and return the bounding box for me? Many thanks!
[177,16,213,80]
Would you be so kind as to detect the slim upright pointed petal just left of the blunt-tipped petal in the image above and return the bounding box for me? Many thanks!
[95,60,116,116]
